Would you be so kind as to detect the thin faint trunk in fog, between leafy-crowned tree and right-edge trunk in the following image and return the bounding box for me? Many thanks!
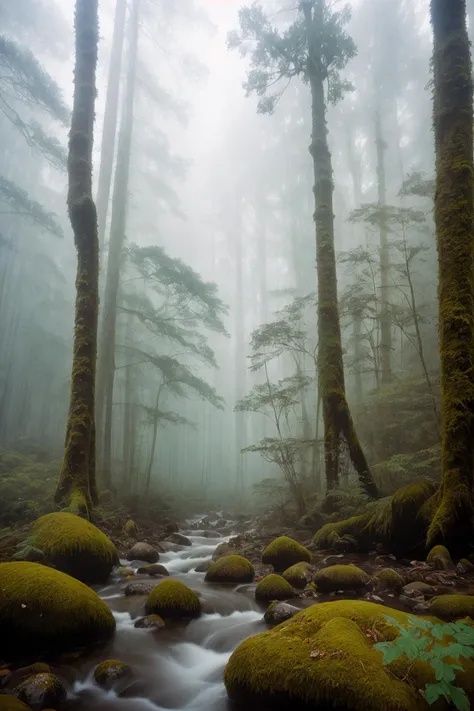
[375,113,392,385]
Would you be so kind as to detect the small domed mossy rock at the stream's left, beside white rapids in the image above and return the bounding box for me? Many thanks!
[145,578,201,620]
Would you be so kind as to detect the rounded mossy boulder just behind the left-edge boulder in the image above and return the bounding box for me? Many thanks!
[20,511,119,583]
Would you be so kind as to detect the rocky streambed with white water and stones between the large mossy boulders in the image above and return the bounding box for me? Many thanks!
[0,519,474,711]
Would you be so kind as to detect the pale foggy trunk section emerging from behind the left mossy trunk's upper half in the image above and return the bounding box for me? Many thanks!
[97,0,127,251]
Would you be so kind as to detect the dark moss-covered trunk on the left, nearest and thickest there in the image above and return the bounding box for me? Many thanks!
[55,0,99,514]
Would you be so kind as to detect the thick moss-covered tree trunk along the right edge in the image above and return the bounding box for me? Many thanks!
[428,0,474,549]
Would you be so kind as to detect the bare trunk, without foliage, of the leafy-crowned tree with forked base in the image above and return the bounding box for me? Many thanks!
[303,3,378,498]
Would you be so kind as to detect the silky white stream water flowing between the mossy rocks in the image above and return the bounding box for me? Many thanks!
[60,531,267,711]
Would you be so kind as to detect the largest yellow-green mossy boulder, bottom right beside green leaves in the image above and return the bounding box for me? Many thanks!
[224,600,474,711]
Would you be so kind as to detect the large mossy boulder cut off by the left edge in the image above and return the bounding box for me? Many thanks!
[0,562,115,659]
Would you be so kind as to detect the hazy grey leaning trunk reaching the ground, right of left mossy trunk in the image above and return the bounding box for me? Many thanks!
[97,0,140,488]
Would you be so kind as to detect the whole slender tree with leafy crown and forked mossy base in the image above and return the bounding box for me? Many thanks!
[229,0,378,498]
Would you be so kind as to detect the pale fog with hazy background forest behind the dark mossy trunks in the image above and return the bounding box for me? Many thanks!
[0,0,460,508]
